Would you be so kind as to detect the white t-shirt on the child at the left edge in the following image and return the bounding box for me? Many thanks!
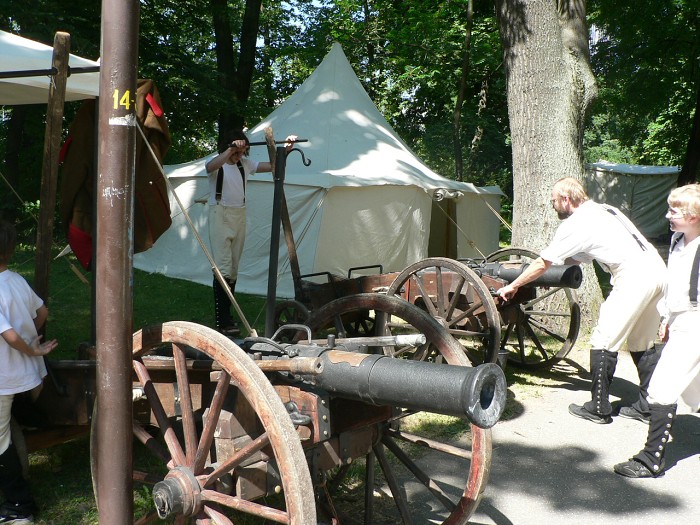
[0,270,46,395]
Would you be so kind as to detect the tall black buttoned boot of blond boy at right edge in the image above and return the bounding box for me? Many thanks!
[613,404,677,478]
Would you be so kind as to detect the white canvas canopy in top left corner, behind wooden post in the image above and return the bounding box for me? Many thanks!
[0,31,100,105]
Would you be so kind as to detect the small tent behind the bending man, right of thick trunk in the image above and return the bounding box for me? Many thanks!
[584,160,680,239]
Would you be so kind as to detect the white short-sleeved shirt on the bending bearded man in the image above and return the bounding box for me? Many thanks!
[540,200,664,276]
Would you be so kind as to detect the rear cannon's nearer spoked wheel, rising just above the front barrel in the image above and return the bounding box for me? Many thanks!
[387,257,505,365]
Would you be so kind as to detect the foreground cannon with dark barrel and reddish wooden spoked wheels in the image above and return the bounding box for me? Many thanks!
[112,294,506,525]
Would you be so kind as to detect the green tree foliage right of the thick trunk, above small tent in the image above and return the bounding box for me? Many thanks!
[588,0,700,174]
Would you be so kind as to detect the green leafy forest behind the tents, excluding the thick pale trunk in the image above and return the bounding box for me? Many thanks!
[0,0,700,235]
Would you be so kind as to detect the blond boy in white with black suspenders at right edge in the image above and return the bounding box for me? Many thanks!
[614,184,700,478]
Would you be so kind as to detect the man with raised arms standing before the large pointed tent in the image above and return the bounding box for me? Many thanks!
[205,130,296,336]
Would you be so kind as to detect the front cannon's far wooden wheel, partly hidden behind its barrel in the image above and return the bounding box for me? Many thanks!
[309,294,492,524]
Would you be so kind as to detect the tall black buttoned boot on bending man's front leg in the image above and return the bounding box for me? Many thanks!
[569,350,617,423]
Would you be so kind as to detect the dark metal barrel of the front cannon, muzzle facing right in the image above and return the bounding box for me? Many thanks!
[313,350,507,428]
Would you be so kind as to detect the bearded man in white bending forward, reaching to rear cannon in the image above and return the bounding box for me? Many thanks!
[497,177,665,423]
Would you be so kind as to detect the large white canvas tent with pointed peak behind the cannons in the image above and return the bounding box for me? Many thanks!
[134,44,501,297]
